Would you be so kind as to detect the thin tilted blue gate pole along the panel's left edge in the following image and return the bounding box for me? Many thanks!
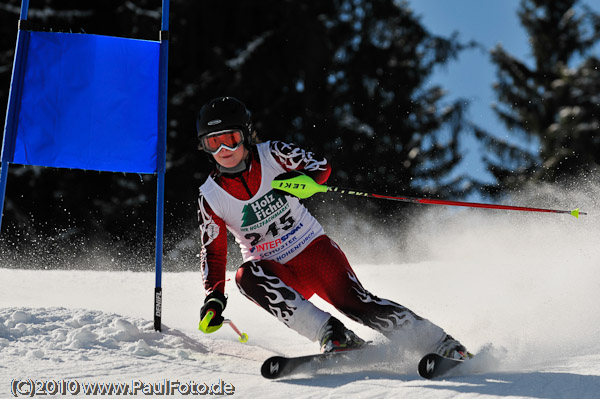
[0,0,29,230]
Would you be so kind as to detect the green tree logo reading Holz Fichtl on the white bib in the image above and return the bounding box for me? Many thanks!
[242,190,289,232]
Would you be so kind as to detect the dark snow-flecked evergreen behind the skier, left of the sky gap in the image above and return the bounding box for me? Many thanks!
[328,1,474,196]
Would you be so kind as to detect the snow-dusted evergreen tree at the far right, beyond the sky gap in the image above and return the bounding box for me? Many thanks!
[477,0,600,193]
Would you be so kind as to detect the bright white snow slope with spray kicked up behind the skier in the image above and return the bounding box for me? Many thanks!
[0,184,600,399]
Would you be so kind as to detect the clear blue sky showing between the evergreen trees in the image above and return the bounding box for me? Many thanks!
[408,0,531,188]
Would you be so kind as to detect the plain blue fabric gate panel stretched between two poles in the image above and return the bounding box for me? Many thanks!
[8,32,160,173]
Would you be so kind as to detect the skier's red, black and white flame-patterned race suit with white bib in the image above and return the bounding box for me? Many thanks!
[198,141,446,347]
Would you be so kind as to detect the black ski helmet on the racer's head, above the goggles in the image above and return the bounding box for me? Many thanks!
[196,97,252,149]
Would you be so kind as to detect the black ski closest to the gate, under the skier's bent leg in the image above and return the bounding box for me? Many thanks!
[260,349,362,380]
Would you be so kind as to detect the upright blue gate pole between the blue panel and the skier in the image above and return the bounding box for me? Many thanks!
[154,0,169,331]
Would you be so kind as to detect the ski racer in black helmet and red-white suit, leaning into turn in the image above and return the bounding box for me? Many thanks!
[197,97,472,360]
